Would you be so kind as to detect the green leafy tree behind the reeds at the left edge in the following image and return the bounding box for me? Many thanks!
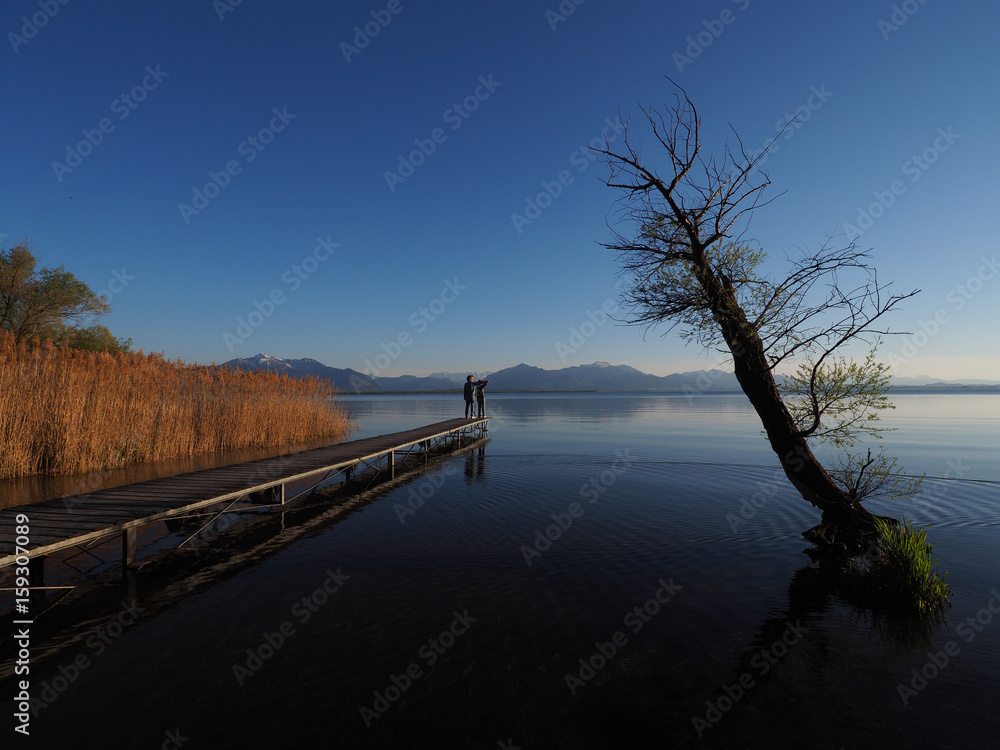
[0,242,132,352]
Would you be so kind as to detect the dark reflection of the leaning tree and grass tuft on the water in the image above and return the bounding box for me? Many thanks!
[691,563,959,748]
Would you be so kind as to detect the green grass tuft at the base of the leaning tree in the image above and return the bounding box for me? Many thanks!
[844,518,952,615]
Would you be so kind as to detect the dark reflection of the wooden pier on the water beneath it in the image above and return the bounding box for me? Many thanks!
[0,438,489,694]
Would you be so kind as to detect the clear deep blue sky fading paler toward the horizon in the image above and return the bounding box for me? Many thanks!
[0,0,1000,379]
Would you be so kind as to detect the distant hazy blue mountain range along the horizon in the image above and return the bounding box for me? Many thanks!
[221,354,1000,393]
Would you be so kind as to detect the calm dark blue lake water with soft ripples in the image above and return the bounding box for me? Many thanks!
[0,393,1000,750]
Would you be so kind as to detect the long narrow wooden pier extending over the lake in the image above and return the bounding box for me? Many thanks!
[0,417,489,568]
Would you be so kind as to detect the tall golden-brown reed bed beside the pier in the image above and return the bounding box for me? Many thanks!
[0,331,354,479]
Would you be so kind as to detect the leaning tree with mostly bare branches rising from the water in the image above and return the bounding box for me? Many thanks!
[598,90,919,548]
